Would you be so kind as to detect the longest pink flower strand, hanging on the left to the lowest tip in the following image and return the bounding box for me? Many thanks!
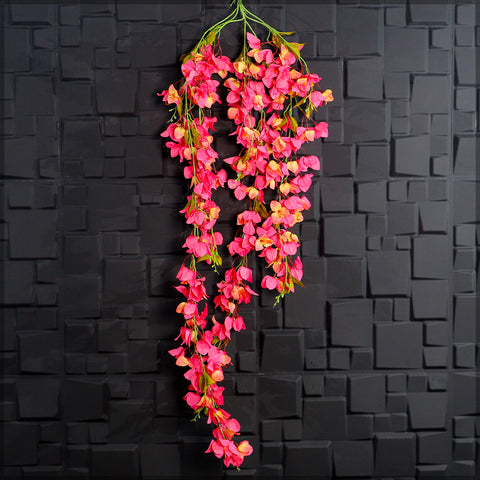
[160,45,253,467]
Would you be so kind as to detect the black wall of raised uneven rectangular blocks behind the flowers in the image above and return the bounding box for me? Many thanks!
[1,0,480,478]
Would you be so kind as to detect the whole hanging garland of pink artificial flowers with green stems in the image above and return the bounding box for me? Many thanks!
[158,0,333,468]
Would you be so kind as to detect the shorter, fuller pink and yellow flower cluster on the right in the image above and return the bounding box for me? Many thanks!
[224,33,332,301]
